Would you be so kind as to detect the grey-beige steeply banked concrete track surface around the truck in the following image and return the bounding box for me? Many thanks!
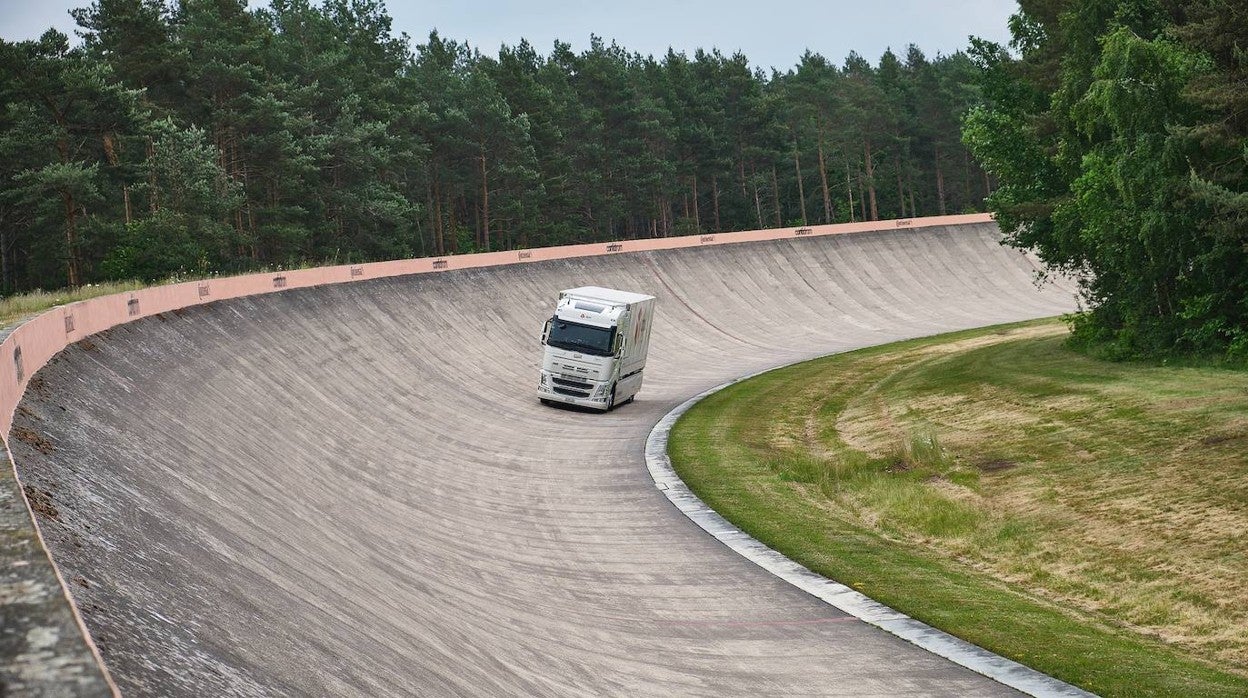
[12,224,1073,696]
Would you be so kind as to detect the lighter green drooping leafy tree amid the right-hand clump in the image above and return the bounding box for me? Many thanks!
[1068,26,1211,353]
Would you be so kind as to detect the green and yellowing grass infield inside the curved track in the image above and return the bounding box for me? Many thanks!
[669,321,1248,696]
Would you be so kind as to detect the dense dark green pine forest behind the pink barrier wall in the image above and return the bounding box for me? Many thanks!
[0,0,992,293]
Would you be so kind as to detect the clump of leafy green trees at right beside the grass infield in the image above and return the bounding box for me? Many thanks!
[966,0,1248,362]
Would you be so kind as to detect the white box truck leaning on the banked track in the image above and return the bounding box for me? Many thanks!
[538,286,654,412]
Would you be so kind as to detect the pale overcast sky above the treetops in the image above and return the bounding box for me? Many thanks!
[0,0,1018,70]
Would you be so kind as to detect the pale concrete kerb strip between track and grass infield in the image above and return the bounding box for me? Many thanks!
[645,374,1094,698]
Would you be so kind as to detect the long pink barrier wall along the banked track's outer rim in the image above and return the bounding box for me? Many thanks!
[0,214,992,445]
